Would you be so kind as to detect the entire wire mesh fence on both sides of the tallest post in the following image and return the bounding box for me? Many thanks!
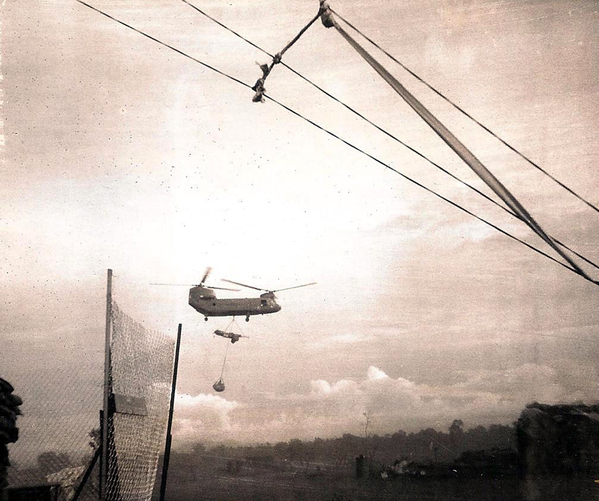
[7,296,175,501]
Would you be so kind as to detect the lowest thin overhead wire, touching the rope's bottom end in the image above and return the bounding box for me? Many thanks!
[76,0,599,285]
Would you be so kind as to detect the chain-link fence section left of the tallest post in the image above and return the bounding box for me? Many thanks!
[8,356,102,500]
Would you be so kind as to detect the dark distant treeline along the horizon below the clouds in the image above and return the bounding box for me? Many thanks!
[188,420,516,465]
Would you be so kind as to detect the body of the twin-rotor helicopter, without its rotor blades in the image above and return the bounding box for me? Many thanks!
[189,286,281,320]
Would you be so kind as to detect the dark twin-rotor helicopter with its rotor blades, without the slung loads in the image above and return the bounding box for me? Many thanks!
[189,268,316,322]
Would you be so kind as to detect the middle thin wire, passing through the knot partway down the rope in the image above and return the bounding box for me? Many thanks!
[181,0,599,269]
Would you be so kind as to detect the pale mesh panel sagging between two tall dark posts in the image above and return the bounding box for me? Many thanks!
[105,303,175,501]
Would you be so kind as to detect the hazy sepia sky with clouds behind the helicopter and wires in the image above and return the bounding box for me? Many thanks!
[0,0,599,454]
